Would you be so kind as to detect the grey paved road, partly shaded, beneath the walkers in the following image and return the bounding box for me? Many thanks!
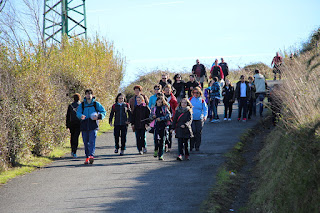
[0,99,264,212]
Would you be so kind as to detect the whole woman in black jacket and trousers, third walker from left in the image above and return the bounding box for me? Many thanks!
[109,93,131,156]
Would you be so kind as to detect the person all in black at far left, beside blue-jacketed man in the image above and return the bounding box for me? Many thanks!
[66,93,81,158]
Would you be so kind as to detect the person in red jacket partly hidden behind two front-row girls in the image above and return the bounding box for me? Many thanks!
[163,85,178,152]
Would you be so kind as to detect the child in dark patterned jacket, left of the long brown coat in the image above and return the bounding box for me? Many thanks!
[150,97,171,160]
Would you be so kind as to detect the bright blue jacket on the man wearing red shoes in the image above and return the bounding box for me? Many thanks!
[77,98,107,131]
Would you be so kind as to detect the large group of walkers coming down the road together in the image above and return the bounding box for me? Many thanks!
[66,58,274,164]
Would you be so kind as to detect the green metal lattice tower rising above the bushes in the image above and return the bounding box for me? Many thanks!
[43,0,87,43]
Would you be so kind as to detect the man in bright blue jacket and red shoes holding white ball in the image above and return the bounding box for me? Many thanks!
[77,89,106,164]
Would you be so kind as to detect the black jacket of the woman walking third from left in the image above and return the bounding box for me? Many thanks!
[109,103,131,125]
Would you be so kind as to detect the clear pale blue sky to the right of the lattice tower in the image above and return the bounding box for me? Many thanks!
[86,0,320,85]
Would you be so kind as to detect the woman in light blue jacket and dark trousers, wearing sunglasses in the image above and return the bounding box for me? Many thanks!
[189,87,208,151]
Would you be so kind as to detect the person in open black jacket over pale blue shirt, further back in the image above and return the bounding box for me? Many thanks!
[235,75,250,122]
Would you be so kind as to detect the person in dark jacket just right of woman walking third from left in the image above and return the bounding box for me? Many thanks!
[131,95,150,155]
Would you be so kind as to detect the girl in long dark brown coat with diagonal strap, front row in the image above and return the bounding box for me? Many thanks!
[172,98,193,161]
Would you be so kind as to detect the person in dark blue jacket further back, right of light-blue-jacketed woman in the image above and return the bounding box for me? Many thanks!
[210,77,221,123]
